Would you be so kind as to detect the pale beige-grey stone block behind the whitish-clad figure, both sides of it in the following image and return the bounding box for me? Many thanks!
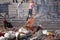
[9,3,28,16]
